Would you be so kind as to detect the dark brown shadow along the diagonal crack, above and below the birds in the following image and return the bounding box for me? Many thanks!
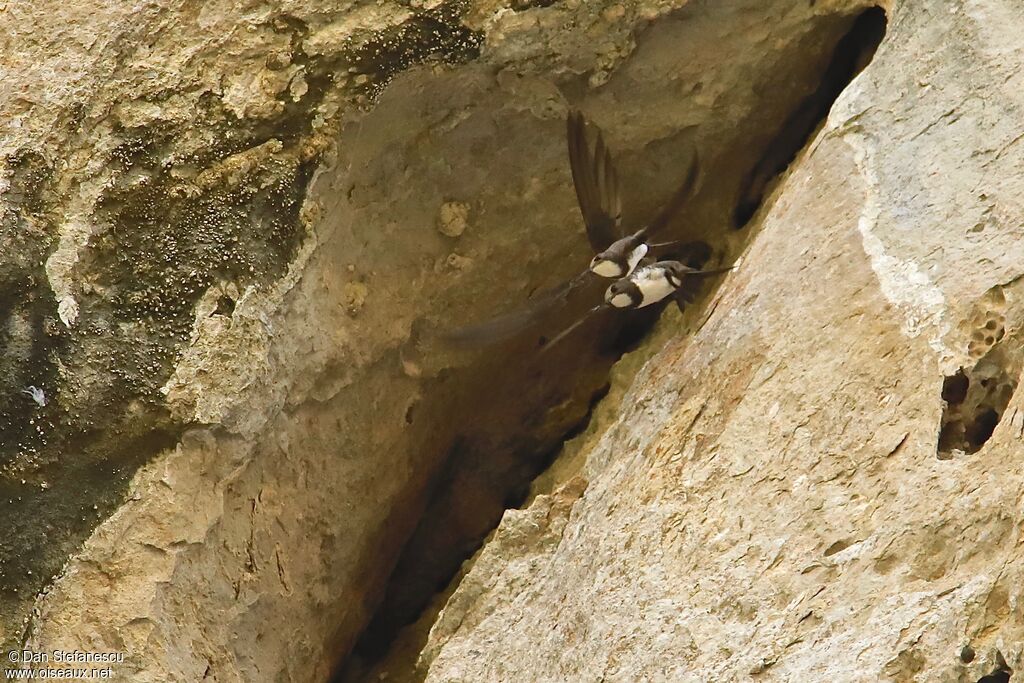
[336,2,886,681]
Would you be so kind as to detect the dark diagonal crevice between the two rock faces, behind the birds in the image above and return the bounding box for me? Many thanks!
[335,5,887,682]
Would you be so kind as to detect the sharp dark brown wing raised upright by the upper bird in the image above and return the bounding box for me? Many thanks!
[565,111,623,253]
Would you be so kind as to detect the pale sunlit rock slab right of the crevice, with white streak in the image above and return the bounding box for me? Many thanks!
[423,0,1024,682]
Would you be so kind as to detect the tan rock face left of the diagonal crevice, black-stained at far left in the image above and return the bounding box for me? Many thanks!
[0,1,831,681]
